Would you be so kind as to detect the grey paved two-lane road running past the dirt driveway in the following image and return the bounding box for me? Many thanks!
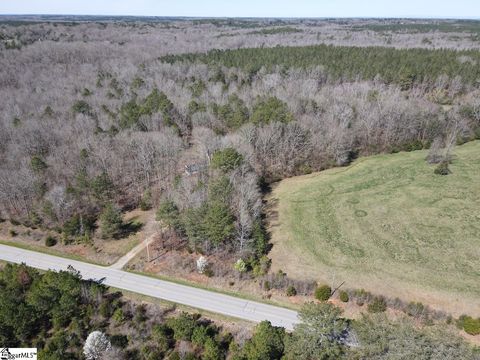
[0,244,298,330]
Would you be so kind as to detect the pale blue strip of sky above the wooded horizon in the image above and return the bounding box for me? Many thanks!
[0,0,480,19]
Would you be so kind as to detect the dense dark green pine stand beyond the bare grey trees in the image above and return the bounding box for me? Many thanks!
[161,45,480,86]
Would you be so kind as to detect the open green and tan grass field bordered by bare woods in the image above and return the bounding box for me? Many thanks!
[269,141,480,316]
